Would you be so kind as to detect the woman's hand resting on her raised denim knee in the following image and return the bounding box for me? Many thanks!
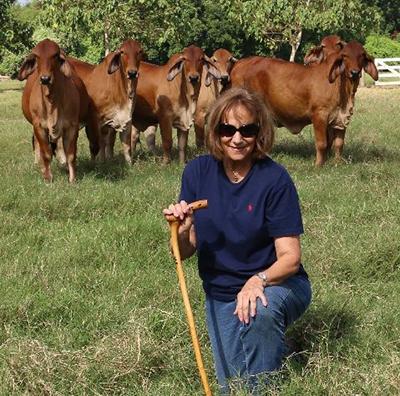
[234,275,268,324]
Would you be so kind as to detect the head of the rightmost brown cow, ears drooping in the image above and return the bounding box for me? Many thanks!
[329,41,378,83]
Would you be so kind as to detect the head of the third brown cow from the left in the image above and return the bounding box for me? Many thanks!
[167,45,221,87]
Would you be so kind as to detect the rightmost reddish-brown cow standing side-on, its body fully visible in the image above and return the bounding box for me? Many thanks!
[231,41,378,166]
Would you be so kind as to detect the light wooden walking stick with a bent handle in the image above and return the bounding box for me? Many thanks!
[166,200,212,396]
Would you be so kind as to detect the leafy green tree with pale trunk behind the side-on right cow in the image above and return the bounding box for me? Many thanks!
[228,0,380,61]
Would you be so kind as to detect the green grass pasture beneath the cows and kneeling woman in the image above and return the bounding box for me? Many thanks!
[0,81,400,396]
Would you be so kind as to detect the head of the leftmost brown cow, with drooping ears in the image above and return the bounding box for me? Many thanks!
[18,39,71,85]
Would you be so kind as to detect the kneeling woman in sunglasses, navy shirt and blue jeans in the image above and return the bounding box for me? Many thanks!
[163,88,311,392]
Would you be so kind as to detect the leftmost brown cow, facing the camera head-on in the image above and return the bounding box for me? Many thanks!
[18,39,98,182]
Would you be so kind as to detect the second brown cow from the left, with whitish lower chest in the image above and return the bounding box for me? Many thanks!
[68,39,143,163]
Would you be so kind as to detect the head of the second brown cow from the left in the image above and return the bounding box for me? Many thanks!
[107,39,144,80]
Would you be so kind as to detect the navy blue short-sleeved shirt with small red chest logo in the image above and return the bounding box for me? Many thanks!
[180,155,304,301]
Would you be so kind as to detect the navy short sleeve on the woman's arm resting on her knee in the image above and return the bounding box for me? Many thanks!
[265,179,304,237]
